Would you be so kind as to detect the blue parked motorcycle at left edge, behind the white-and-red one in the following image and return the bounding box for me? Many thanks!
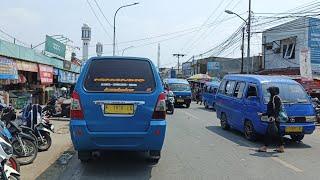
[1,107,38,165]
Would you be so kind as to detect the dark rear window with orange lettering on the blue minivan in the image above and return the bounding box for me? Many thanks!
[84,59,156,93]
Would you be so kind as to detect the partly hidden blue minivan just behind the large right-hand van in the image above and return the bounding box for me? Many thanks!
[202,82,220,109]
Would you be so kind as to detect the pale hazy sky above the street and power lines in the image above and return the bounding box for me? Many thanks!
[0,0,313,67]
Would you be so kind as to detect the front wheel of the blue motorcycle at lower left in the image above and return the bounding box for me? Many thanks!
[12,139,38,165]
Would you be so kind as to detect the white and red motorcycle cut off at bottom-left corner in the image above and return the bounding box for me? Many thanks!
[0,137,20,180]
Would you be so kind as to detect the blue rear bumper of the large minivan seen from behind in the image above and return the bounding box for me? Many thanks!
[70,120,166,151]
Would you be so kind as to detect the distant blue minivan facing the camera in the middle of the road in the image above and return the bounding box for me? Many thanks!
[164,78,192,108]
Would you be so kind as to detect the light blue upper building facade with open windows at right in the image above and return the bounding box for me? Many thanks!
[262,17,320,75]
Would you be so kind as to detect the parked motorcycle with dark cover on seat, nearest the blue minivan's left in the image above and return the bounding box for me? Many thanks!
[20,105,54,151]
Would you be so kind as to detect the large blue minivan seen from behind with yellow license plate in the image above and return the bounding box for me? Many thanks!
[70,57,166,162]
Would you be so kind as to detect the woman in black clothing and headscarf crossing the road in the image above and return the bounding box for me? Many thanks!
[258,86,284,153]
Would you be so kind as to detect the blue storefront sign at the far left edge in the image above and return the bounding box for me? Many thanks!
[0,57,18,80]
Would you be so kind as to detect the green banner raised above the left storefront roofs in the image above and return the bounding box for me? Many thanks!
[44,35,66,58]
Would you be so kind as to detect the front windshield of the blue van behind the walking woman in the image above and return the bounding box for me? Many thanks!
[262,82,310,103]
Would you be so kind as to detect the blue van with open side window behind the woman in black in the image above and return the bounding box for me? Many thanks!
[215,75,316,141]
